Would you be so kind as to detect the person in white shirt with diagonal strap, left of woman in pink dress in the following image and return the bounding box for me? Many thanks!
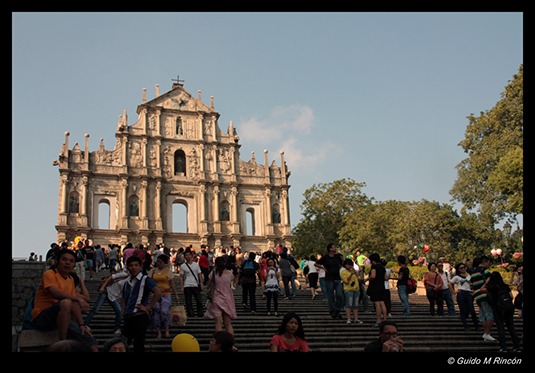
[180,250,204,317]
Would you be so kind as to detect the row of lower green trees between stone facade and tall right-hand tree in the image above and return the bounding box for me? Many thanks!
[292,179,522,264]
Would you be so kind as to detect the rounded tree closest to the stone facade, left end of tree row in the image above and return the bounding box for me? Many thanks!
[292,178,370,255]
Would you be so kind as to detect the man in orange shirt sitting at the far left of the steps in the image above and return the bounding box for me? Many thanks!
[32,249,98,352]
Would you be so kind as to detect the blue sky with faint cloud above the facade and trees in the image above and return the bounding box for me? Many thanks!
[12,13,523,257]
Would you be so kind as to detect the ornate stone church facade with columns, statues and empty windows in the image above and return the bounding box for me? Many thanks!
[54,79,293,251]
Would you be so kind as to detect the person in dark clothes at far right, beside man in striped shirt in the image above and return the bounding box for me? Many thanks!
[487,272,521,352]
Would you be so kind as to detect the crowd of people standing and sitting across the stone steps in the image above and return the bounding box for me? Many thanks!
[25,238,523,352]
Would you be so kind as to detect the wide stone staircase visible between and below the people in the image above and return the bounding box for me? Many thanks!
[82,271,523,353]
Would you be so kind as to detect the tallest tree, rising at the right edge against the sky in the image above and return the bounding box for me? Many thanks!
[450,65,524,222]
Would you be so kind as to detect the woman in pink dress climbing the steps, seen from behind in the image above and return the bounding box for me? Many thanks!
[204,257,237,335]
